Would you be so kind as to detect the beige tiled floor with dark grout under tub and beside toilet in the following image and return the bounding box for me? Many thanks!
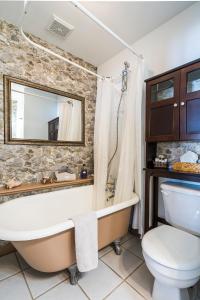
[0,234,153,300]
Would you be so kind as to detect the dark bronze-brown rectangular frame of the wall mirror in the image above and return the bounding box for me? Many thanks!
[3,75,85,146]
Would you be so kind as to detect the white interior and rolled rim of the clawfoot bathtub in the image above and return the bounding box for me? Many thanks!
[0,185,139,241]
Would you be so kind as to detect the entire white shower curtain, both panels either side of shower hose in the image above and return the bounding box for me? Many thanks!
[94,59,143,234]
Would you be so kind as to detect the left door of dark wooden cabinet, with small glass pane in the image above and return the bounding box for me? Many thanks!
[146,71,180,142]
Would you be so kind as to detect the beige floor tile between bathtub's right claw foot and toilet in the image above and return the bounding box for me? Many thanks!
[101,249,142,279]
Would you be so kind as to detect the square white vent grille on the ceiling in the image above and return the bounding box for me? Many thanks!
[48,15,74,38]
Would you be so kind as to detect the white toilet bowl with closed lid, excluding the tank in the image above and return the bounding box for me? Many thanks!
[142,225,200,300]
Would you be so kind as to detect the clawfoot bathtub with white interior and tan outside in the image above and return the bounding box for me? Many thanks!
[0,185,139,272]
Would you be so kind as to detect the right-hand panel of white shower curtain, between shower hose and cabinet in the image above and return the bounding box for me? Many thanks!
[115,59,144,234]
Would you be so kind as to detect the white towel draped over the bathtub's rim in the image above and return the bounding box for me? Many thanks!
[72,212,98,272]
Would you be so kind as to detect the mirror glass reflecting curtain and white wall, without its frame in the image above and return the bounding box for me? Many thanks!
[10,82,83,142]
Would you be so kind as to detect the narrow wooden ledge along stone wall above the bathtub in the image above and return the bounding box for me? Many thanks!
[0,177,93,196]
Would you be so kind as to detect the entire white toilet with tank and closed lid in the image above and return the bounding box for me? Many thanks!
[142,182,200,300]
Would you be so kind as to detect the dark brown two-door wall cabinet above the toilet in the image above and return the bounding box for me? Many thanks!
[146,62,200,142]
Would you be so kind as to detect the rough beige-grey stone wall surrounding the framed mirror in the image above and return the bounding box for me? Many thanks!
[0,20,97,184]
